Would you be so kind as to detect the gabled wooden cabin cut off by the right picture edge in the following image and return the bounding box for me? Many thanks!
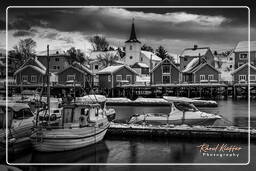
[232,63,256,84]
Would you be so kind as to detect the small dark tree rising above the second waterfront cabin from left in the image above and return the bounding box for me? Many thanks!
[67,47,85,64]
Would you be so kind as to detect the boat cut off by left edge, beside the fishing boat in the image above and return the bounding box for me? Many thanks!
[0,102,34,153]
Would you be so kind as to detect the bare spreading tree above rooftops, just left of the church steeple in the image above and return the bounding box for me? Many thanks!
[89,35,109,51]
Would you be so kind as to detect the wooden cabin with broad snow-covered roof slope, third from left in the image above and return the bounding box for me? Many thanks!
[98,65,138,89]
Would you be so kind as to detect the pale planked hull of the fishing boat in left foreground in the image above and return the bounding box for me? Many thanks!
[30,123,109,152]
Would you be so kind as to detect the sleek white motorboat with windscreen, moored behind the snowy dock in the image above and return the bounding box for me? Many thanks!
[128,96,222,126]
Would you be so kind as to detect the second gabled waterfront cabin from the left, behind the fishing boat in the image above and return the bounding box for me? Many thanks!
[57,62,93,87]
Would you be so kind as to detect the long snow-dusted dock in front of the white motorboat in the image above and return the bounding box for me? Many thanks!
[106,123,256,141]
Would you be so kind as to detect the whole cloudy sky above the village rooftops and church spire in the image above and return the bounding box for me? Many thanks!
[0,7,255,54]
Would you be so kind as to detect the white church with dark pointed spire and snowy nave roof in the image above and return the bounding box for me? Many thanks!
[124,20,162,70]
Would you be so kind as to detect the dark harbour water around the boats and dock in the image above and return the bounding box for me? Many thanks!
[2,99,256,170]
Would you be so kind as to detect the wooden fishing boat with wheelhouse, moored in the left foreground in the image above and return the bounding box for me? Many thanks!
[30,96,109,152]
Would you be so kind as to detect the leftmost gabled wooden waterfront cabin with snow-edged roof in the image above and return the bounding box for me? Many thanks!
[14,58,46,85]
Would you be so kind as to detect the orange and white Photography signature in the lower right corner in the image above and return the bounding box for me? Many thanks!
[196,143,242,157]
